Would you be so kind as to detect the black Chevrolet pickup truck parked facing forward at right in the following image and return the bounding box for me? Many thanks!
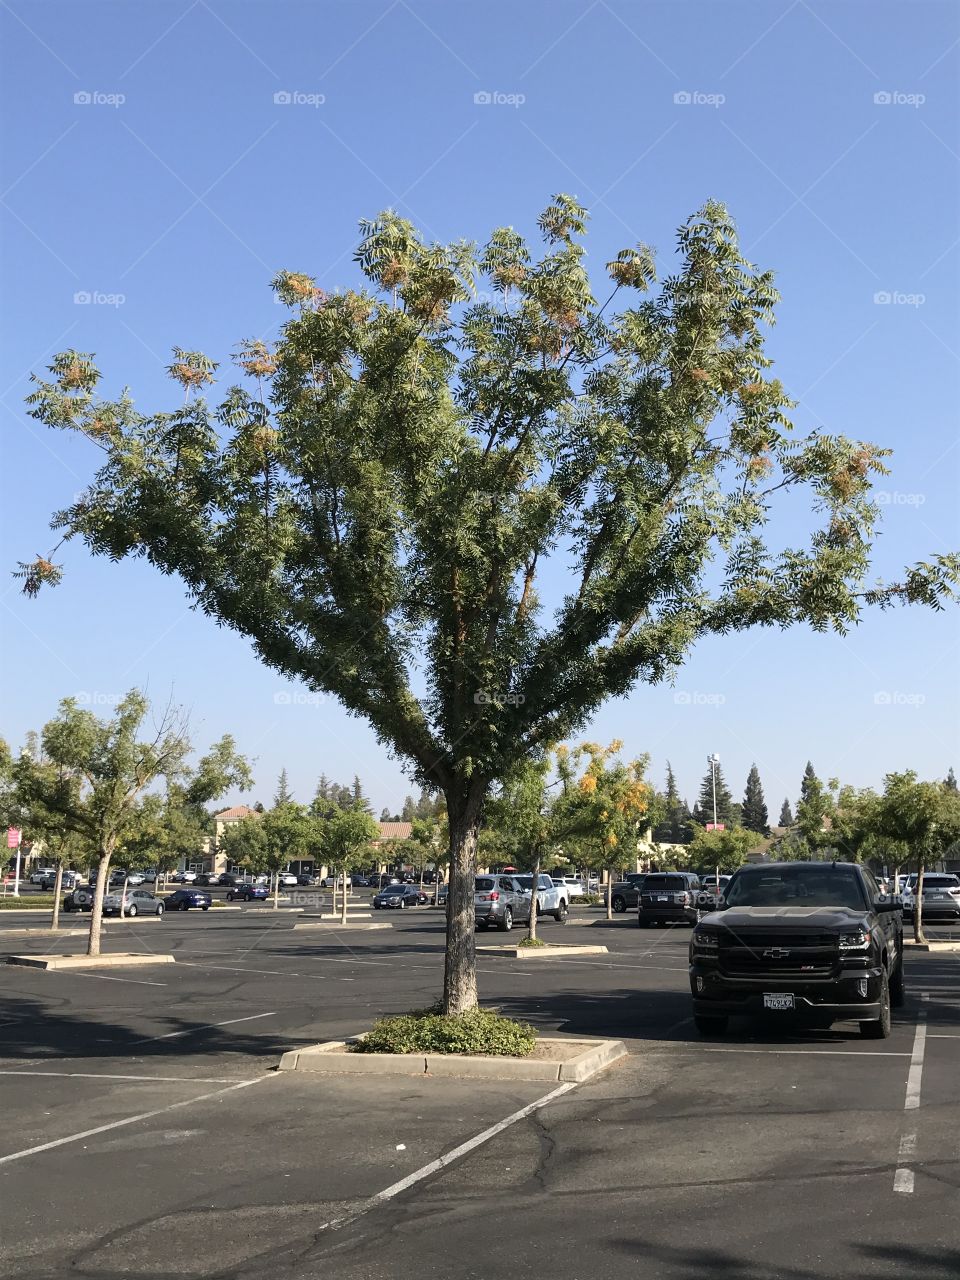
[690,863,904,1039]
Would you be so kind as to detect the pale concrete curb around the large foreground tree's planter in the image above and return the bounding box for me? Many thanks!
[279,1036,627,1083]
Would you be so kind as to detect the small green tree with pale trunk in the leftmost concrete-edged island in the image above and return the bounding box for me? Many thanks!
[18,689,189,956]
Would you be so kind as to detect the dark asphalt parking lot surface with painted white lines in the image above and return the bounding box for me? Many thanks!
[0,910,960,1280]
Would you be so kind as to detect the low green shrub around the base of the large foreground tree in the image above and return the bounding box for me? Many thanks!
[351,1009,536,1057]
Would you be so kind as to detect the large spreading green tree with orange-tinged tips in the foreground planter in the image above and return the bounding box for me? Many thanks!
[19,196,960,1011]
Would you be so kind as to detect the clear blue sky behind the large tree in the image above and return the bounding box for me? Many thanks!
[0,0,960,815]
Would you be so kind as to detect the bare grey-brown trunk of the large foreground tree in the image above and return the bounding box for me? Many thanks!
[443,783,486,1014]
